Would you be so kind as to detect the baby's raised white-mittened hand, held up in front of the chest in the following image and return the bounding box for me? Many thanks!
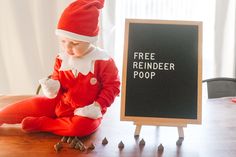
[39,78,60,98]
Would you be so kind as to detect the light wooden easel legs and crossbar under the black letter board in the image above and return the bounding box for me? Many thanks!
[134,122,187,146]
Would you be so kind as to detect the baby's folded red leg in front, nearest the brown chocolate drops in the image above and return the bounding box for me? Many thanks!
[22,116,101,137]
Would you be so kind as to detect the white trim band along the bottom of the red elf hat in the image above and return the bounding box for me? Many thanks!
[55,29,98,43]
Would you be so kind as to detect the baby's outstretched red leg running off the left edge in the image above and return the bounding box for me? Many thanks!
[0,96,56,124]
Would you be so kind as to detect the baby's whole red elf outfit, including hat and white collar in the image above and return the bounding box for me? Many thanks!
[0,0,120,136]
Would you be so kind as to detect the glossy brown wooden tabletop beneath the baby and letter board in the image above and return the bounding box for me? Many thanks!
[0,92,236,157]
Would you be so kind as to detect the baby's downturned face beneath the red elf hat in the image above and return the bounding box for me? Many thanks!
[59,37,92,57]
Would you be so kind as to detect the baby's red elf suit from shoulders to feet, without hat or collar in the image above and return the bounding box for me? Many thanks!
[0,47,120,136]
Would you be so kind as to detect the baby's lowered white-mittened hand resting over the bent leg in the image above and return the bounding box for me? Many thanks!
[74,102,102,119]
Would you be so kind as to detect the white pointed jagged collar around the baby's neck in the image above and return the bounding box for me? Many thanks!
[59,47,110,77]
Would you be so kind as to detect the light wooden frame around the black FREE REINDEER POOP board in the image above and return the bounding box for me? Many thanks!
[121,19,202,127]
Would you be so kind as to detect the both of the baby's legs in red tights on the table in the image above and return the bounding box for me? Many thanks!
[0,97,101,137]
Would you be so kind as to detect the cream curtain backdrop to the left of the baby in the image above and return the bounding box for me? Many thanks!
[0,0,72,94]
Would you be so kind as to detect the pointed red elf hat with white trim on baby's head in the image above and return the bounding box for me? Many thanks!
[56,0,104,42]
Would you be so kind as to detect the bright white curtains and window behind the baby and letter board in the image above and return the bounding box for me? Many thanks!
[0,0,236,95]
